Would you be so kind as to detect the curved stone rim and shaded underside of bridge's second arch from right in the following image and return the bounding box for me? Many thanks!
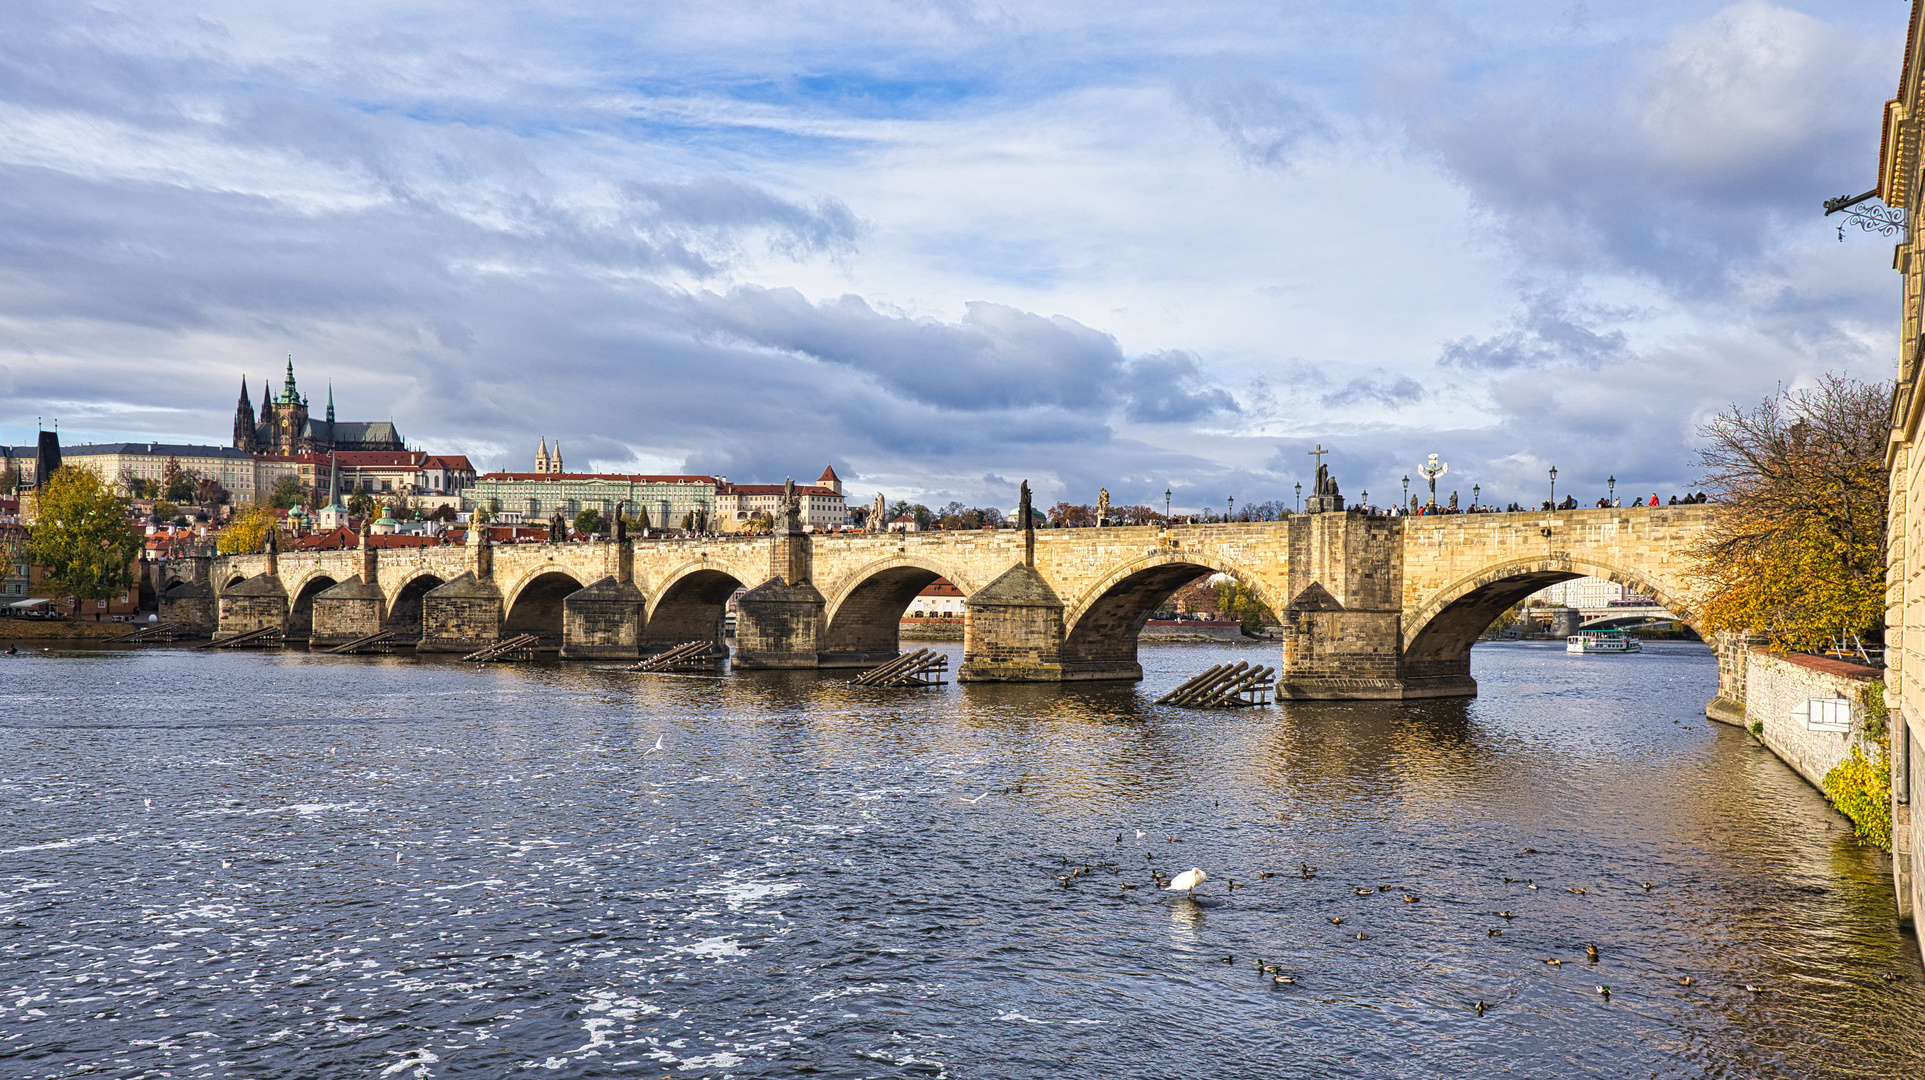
[1063,551,1282,680]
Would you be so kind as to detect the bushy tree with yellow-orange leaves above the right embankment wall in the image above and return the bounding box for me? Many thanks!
[1694,375,1892,651]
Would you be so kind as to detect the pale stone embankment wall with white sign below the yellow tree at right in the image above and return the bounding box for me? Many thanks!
[1744,649,1883,789]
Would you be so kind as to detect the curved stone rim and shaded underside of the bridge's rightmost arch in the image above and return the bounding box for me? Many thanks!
[1403,554,1698,693]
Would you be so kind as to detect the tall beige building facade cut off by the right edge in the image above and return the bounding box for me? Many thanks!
[1875,0,1925,951]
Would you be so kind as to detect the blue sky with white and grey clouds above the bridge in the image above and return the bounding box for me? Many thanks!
[0,0,1908,508]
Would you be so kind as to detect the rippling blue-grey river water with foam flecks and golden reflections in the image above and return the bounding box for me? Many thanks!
[0,643,1925,1080]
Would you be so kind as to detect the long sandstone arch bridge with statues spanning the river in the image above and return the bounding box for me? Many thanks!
[169,506,1707,699]
